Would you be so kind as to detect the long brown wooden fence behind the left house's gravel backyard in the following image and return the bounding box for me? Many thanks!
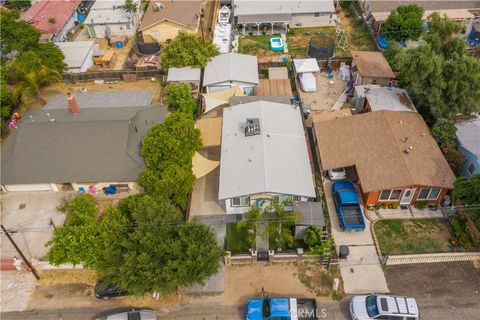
[62,70,164,82]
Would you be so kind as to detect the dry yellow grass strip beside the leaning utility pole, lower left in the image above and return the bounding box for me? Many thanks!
[37,269,97,287]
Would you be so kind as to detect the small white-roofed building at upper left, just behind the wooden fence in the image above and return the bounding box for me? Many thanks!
[56,41,94,73]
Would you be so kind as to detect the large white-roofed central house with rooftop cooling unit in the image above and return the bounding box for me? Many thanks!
[218,101,315,214]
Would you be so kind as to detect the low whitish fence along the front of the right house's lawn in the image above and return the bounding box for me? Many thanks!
[385,252,480,266]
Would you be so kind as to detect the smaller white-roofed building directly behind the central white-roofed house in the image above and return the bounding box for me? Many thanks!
[203,53,259,96]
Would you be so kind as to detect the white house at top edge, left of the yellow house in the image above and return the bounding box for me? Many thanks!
[84,0,142,38]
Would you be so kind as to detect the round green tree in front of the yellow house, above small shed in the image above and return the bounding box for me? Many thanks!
[161,32,219,70]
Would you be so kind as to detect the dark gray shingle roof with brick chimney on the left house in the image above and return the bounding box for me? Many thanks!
[1,102,167,184]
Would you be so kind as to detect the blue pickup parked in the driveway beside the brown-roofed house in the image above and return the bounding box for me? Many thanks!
[332,180,365,231]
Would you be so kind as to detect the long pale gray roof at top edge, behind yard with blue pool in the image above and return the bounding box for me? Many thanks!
[233,0,335,16]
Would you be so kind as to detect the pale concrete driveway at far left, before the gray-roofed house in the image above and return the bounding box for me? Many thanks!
[0,191,71,259]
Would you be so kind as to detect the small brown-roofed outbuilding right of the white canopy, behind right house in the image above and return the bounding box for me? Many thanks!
[351,51,395,86]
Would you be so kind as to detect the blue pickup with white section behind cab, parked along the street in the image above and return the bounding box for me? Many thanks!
[246,297,318,320]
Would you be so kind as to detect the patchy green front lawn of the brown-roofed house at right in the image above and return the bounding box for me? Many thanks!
[375,219,451,256]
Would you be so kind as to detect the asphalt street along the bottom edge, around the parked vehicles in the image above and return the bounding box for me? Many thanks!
[1,297,480,320]
